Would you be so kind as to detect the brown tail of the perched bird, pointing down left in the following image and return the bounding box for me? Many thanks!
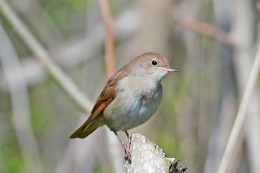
[70,116,105,138]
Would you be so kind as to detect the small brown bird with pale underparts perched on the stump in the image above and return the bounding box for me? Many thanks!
[70,52,177,160]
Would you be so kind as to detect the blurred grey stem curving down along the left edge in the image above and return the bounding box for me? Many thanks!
[0,24,44,173]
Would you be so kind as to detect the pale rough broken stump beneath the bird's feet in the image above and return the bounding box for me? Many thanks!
[124,134,187,173]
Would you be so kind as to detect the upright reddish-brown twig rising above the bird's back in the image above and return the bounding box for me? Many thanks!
[99,0,115,77]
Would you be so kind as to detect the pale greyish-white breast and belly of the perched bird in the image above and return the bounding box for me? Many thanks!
[104,77,162,131]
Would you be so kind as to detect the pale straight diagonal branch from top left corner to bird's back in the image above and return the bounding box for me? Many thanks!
[0,0,92,111]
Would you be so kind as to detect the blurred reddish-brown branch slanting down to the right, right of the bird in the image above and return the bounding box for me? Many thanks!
[171,9,239,49]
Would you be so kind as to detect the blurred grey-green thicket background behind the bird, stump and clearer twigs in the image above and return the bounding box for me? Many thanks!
[0,0,260,173]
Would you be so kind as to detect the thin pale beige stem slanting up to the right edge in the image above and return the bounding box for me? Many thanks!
[218,44,260,173]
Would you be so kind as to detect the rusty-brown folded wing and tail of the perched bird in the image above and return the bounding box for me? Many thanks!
[70,68,126,138]
